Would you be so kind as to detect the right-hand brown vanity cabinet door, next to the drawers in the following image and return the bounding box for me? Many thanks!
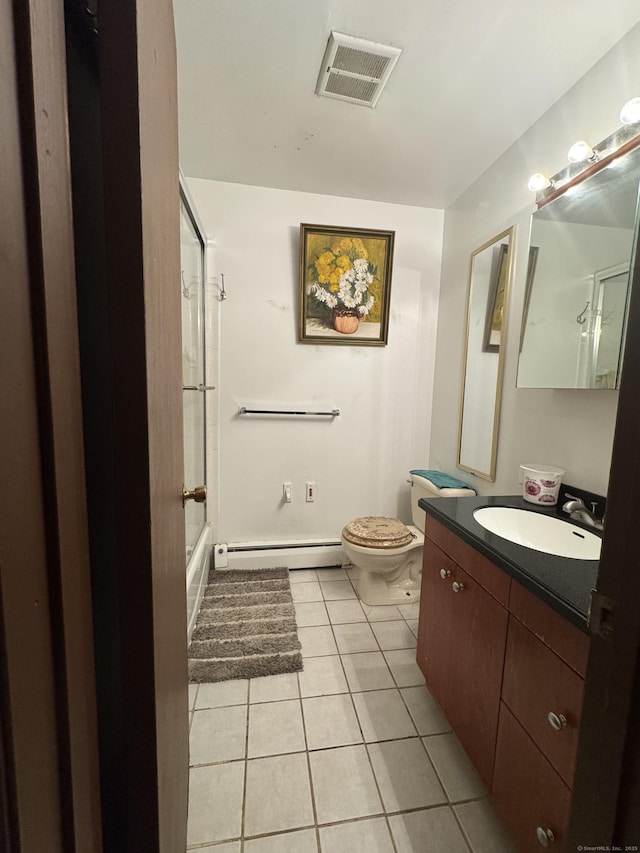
[446,568,508,790]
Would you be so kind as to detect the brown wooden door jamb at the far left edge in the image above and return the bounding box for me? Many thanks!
[0,0,101,853]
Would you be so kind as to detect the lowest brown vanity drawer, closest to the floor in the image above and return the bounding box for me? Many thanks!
[492,704,571,853]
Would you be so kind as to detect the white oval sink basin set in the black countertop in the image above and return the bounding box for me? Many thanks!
[473,506,602,560]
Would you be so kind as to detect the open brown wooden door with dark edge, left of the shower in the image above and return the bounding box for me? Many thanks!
[68,0,188,853]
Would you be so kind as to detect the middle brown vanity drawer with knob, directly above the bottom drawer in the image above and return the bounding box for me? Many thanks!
[502,616,584,787]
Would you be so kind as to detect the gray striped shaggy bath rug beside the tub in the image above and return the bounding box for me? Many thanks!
[189,569,302,682]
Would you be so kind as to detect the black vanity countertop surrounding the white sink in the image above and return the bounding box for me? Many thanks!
[419,495,600,633]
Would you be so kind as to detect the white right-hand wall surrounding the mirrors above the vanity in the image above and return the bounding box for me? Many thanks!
[430,21,640,494]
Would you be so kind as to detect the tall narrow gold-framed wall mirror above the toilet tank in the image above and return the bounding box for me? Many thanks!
[458,227,514,480]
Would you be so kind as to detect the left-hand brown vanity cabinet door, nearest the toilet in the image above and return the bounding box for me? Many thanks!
[417,538,459,716]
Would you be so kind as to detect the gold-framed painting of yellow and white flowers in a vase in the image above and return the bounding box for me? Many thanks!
[300,224,395,346]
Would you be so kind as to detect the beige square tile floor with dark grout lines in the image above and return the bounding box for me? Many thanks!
[187,569,514,853]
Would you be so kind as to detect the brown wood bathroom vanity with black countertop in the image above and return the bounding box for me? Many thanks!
[417,497,598,853]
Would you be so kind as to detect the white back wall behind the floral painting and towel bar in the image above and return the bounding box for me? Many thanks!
[189,179,443,542]
